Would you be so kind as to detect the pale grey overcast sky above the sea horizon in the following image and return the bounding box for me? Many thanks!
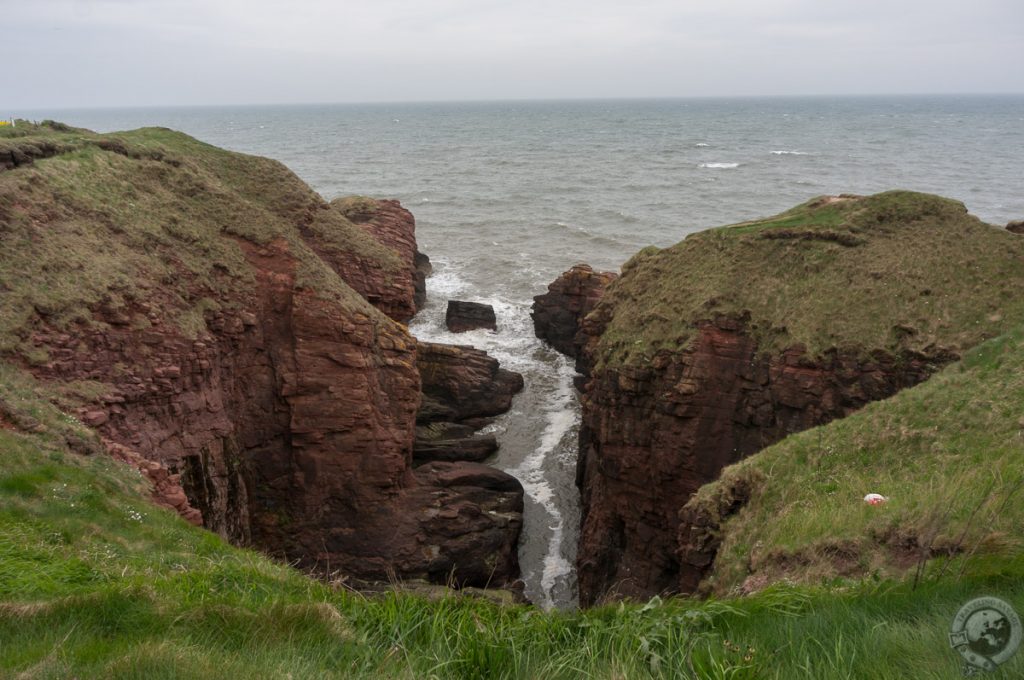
[8,0,1024,108]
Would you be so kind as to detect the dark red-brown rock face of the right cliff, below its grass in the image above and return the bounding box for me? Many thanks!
[577,316,955,605]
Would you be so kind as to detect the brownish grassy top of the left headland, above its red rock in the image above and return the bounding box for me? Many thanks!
[0,123,402,353]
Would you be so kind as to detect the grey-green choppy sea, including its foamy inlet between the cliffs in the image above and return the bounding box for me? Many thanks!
[16,96,1024,607]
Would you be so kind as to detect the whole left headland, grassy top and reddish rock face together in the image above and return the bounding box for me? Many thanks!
[0,125,522,586]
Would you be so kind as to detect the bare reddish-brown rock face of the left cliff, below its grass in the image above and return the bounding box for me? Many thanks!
[29,229,522,586]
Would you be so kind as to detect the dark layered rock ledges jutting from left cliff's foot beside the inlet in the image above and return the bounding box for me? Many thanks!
[399,342,523,587]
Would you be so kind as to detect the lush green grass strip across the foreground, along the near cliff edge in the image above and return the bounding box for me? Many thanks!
[0,358,1024,680]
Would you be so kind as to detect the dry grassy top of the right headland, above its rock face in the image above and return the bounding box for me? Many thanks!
[596,192,1024,365]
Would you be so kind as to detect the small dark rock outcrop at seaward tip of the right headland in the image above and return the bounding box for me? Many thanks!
[530,264,618,373]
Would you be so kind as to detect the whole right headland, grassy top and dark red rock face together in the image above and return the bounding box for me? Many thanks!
[534,192,1024,606]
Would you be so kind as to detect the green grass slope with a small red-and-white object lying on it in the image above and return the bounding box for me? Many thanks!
[690,327,1024,593]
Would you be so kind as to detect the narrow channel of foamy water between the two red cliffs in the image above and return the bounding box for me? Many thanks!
[410,260,580,608]
